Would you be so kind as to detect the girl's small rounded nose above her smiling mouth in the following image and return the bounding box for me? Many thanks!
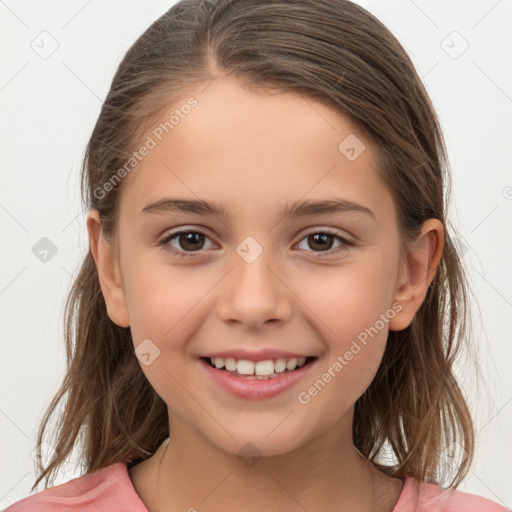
[218,247,293,330]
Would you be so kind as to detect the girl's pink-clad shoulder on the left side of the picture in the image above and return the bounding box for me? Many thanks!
[4,462,147,512]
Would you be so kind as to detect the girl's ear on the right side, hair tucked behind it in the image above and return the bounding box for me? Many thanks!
[389,219,444,331]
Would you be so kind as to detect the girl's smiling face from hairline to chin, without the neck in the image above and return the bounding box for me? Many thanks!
[91,78,440,460]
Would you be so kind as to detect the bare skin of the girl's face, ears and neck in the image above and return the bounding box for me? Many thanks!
[87,77,443,512]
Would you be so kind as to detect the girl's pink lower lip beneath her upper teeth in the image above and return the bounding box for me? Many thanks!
[199,358,318,400]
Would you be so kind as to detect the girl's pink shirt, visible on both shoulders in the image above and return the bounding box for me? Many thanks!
[4,462,509,512]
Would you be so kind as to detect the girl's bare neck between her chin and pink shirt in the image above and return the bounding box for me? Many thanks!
[132,416,401,512]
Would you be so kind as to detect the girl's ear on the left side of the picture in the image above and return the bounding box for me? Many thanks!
[87,209,130,327]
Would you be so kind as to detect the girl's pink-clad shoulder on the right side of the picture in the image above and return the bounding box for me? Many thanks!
[393,475,510,512]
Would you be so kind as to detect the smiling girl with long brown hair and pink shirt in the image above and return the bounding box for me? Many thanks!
[7,0,506,512]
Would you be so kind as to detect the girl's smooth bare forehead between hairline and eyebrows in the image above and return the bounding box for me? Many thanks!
[121,78,393,226]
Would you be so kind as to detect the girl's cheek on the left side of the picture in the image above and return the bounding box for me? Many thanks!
[125,257,207,409]
